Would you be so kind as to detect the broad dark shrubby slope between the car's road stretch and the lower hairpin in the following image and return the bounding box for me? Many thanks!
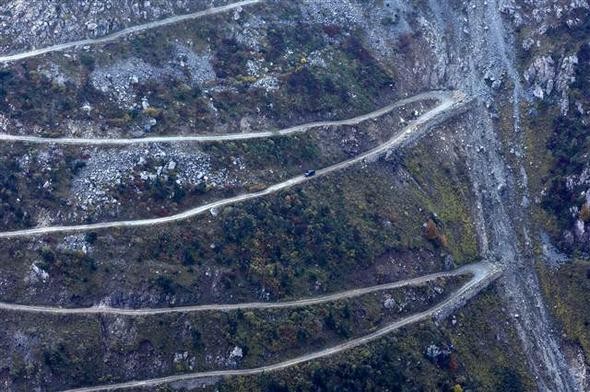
[0,135,475,303]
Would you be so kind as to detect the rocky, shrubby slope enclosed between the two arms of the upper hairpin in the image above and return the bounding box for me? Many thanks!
[0,102,432,233]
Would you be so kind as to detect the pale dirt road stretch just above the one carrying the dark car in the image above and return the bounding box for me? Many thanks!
[0,91,449,145]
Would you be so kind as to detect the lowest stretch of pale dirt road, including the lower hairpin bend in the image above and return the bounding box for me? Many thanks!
[61,262,502,392]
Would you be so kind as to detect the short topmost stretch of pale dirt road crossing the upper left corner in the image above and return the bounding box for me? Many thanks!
[0,0,263,63]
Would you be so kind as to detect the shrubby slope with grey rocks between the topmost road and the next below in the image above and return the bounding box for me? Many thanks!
[0,2,395,136]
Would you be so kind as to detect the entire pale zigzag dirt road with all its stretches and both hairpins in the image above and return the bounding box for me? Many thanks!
[0,0,502,392]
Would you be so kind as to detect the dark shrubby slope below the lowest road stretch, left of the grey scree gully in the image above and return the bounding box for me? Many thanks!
[216,289,535,392]
